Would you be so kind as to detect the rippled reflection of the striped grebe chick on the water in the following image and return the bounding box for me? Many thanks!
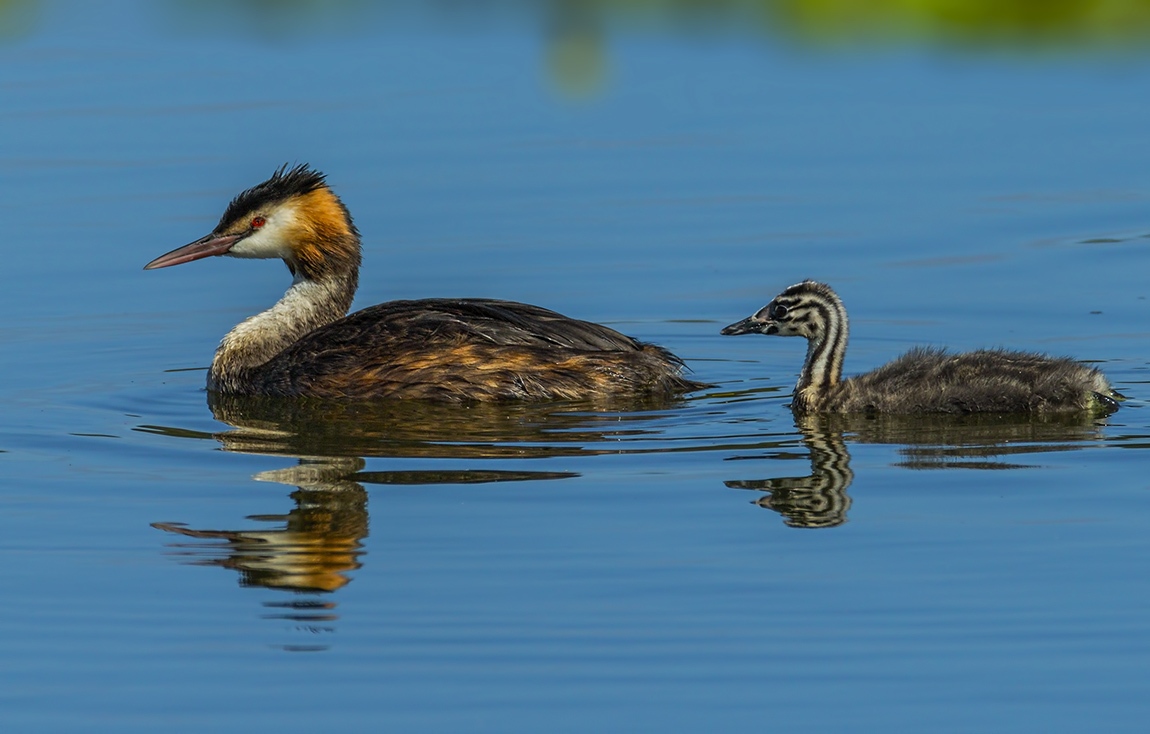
[725,414,1103,528]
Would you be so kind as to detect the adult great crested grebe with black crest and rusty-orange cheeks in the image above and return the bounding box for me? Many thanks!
[144,165,705,402]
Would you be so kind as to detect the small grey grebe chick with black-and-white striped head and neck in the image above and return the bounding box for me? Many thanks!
[722,281,1124,414]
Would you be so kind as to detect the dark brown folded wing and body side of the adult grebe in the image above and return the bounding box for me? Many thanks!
[253,299,703,402]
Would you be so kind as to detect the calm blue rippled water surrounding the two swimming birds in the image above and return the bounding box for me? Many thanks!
[0,0,1150,732]
